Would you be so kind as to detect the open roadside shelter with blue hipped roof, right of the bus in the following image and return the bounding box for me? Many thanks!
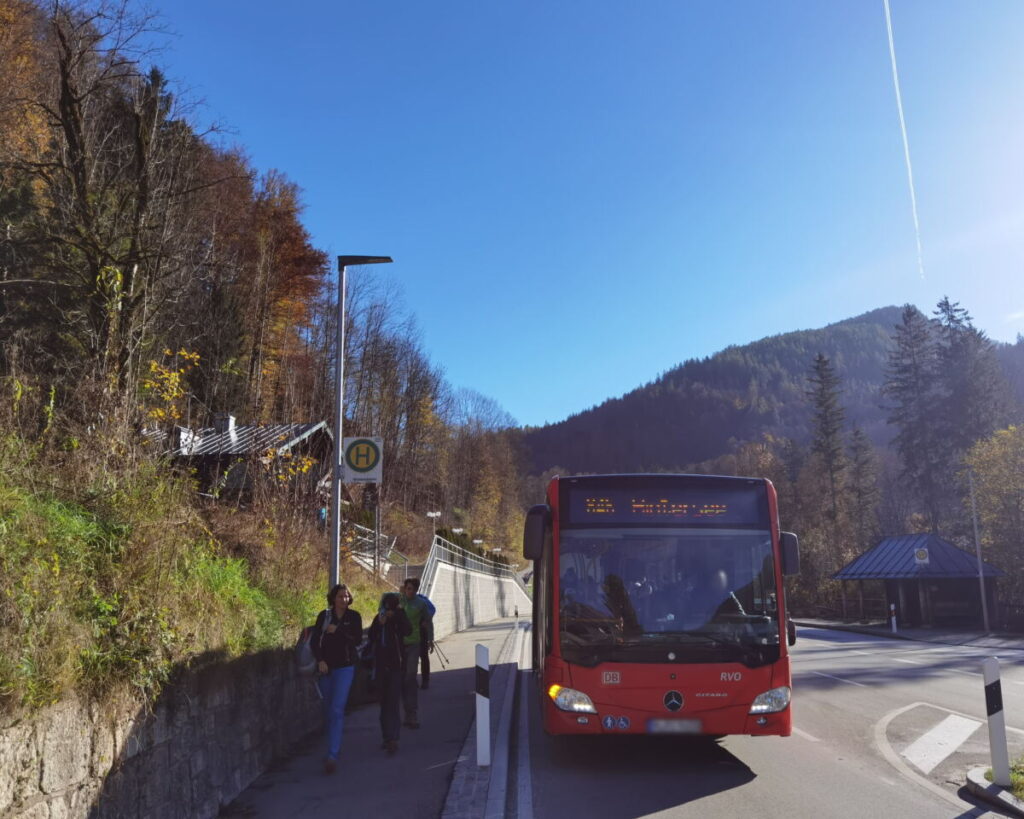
[833,533,1002,626]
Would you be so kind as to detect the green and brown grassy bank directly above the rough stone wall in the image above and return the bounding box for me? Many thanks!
[0,433,385,714]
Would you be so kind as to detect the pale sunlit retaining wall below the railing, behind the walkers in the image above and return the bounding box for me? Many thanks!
[423,563,532,640]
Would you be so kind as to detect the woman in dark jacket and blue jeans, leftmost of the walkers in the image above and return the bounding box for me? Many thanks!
[309,585,362,774]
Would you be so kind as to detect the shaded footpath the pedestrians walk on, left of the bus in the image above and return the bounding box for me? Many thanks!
[221,619,515,819]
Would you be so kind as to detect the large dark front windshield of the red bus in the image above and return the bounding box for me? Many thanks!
[558,527,779,666]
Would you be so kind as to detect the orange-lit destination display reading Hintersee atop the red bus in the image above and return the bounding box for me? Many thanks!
[568,487,767,527]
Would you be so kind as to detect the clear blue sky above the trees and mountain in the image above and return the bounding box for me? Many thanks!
[148,0,1024,424]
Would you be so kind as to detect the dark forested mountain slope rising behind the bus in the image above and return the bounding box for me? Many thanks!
[524,307,1024,474]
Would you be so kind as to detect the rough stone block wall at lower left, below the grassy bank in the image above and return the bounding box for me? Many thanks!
[0,650,321,819]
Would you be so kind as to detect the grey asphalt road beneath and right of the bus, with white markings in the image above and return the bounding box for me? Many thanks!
[518,629,1024,819]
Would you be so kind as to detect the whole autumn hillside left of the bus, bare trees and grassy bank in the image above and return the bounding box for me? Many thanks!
[0,0,522,713]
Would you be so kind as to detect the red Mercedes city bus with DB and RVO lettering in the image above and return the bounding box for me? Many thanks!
[523,475,800,736]
